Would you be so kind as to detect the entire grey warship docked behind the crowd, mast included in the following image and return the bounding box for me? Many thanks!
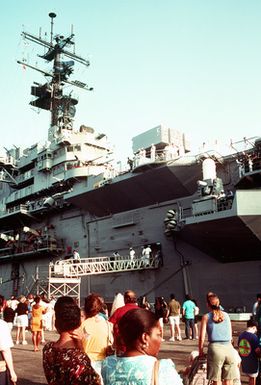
[0,13,261,313]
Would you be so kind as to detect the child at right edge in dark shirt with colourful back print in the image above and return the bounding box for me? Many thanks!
[238,319,260,385]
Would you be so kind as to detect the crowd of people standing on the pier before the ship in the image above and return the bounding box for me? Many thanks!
[0,290,261,385]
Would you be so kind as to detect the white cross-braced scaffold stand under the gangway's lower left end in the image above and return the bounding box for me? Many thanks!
[48,277,81,305]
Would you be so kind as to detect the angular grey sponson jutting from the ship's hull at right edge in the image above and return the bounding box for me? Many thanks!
[180,189,261,262]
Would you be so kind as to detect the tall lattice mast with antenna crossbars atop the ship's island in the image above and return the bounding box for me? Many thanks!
[18,12,93,140]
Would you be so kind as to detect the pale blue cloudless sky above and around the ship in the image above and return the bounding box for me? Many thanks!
[0,0,261,159]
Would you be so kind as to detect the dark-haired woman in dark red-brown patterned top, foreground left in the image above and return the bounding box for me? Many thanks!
[43,297,101,385]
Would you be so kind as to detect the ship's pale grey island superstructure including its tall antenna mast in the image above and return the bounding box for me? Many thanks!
[0,13,111,243]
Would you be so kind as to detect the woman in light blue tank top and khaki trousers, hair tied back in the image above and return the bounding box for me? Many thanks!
[199,293,237,385]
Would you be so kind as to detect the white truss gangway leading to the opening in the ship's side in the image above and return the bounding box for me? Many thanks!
[49,256,161,277]
